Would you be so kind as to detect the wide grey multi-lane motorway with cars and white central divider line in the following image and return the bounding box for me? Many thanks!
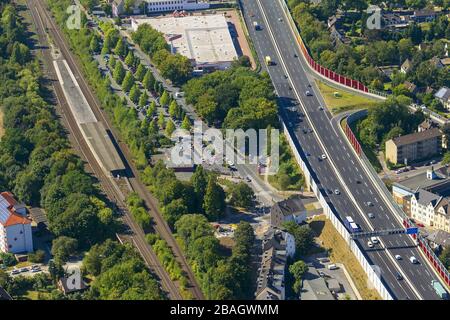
[241,0,438,299]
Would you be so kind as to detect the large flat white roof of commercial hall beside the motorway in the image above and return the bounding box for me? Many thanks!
[135,14,238,65]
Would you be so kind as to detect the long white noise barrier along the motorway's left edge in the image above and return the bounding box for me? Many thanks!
[281,121,393,300]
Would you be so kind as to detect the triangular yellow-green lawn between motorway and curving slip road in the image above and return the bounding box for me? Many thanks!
[316,80,378,114]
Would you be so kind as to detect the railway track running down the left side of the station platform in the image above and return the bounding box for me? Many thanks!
[27,0,182,300]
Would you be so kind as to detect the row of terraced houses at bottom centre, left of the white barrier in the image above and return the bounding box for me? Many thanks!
[255,228,295,300]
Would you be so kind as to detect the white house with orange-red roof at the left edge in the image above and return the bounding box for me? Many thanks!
[0,192,33,253]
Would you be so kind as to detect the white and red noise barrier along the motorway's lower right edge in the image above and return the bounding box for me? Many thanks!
[344,110,450,286]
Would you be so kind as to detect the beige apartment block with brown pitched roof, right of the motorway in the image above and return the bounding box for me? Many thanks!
[385,128,442,164]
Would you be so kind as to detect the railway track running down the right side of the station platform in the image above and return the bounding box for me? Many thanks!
[32,0,205,300]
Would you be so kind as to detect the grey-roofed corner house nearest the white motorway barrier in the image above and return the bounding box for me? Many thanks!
[270,196,307,228]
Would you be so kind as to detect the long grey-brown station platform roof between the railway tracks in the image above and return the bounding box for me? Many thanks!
[80,122,125,172]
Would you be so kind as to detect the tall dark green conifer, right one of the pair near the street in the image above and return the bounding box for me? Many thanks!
[203,177,226,221]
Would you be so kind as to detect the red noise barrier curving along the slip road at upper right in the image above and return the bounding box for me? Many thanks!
[280,0,387,97]
